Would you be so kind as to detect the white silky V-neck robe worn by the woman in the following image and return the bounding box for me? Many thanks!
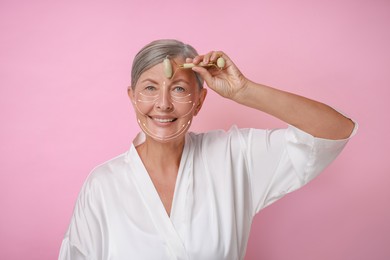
[59,126,356,260]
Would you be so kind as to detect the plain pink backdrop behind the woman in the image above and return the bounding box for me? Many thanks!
[0,0,390,260]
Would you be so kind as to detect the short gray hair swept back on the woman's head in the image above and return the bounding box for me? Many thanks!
[131,39,203,89]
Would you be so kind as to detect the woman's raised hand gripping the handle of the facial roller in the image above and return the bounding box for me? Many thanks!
[186,51,248,99]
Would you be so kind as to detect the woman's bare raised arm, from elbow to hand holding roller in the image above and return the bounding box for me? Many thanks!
[191,52,354,140]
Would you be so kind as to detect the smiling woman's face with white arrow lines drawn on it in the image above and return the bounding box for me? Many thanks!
[129,59,206,142]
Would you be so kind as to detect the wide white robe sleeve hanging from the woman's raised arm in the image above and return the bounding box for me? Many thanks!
[246,123,357,214]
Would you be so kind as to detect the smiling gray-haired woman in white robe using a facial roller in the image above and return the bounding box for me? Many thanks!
[59,40,356,260]
